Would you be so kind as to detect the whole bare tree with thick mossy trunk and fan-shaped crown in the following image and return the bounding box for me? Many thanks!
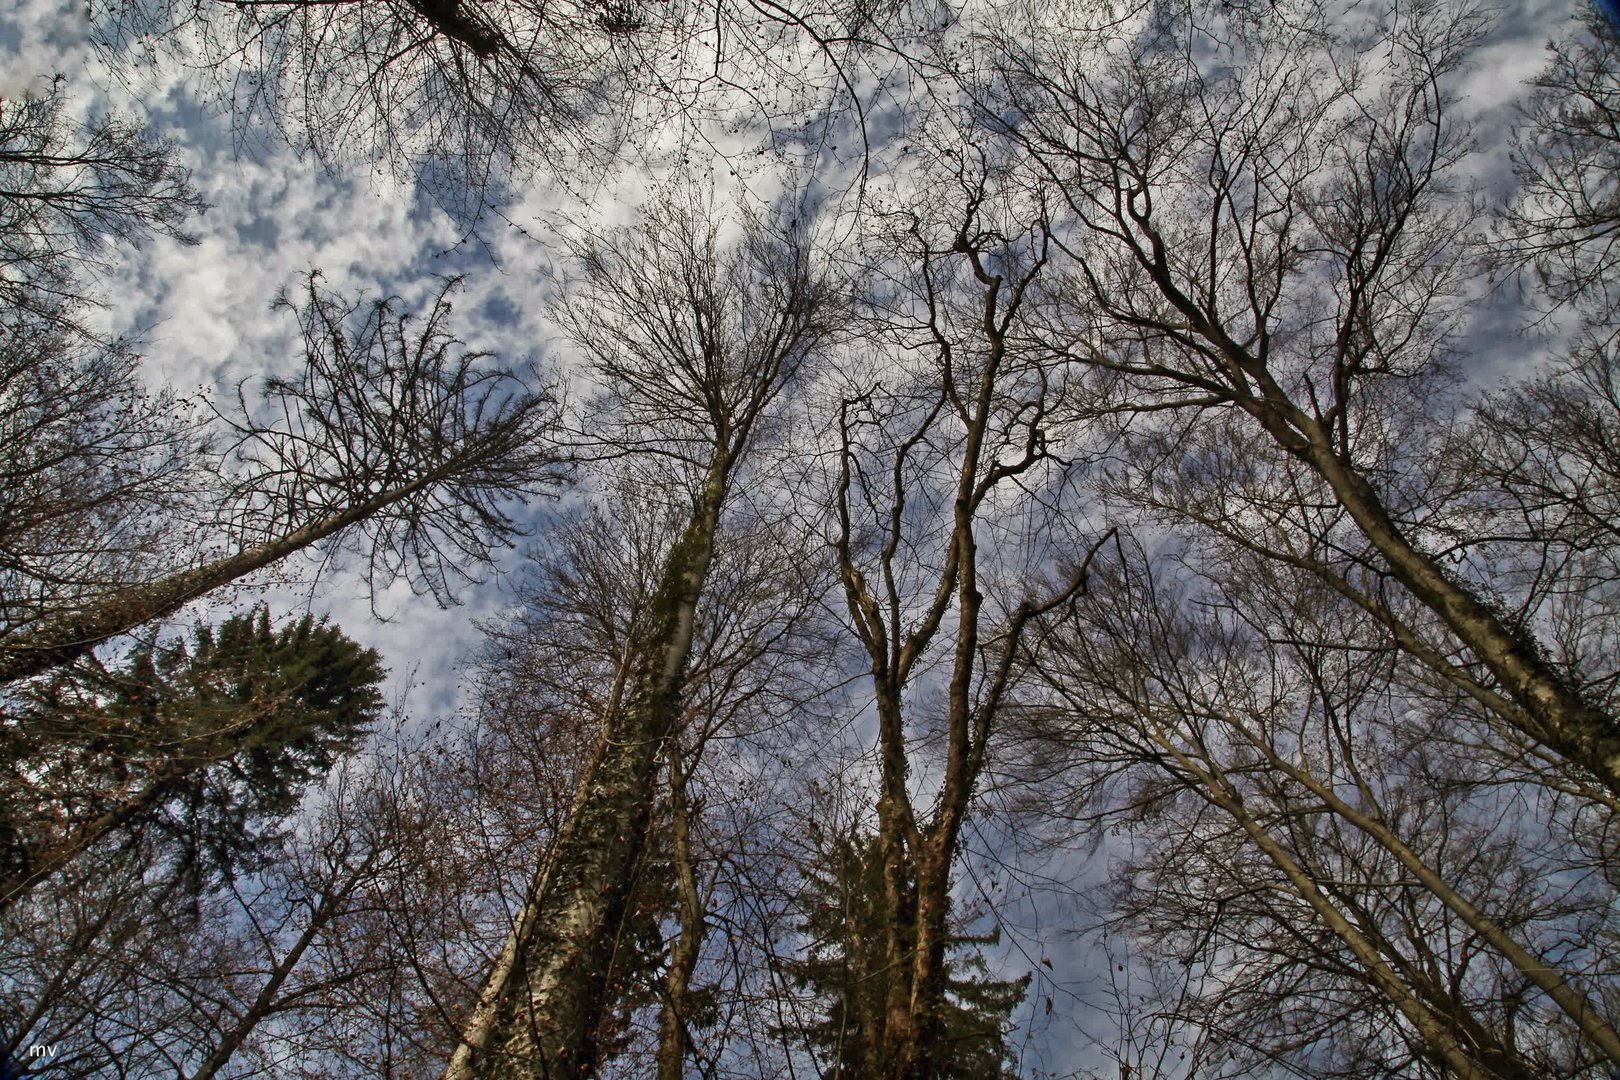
[446,194,831,1078]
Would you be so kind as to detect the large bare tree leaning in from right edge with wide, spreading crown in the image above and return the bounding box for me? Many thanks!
[987,3,1620,792]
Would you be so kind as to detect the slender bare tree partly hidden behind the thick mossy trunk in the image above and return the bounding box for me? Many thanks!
[484,498,825,1077]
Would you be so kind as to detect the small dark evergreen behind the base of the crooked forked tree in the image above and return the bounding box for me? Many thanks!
[784,834,1030,1080]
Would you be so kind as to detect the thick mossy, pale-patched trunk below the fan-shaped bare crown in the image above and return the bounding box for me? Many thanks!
[446,450,729,1080]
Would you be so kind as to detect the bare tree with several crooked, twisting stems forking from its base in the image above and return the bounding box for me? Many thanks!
[831,151,1108,1078]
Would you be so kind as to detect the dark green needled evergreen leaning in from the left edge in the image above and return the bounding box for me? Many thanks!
[0,607,386,904]
